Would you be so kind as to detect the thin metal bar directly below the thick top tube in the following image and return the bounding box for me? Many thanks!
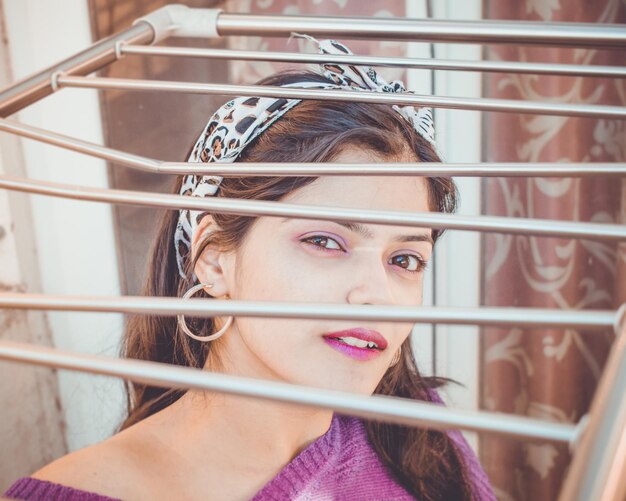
[120,44,626,78]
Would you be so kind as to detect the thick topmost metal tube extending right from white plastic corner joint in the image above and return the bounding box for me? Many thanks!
[212,12,626,47]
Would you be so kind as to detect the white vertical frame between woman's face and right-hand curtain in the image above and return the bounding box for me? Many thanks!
[407,0,482,454]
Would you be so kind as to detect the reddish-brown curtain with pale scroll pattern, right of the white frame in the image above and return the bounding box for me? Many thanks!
[480,0,626,501]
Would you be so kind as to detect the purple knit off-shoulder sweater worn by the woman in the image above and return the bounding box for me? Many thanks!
[4,392,496,501]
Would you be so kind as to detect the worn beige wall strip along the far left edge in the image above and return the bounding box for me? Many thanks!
[0,2,67,484]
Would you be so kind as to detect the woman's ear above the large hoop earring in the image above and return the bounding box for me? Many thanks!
[191,214,231,297]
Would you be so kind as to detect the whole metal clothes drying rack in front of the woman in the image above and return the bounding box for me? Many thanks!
[0,5,626,501]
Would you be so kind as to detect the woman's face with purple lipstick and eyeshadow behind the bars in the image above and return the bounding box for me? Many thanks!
[196,149,432,394]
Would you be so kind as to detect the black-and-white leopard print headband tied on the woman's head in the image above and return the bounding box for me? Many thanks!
[174,33,436,282]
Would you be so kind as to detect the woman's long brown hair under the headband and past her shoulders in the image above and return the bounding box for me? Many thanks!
[119,71,471,500]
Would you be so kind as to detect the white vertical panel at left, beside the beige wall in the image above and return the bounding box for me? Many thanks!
[4,0,122,450]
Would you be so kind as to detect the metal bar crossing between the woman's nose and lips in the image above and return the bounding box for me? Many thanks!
[0,293,616,330]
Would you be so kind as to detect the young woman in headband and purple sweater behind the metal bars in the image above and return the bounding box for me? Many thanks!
[7,41,495,501]
